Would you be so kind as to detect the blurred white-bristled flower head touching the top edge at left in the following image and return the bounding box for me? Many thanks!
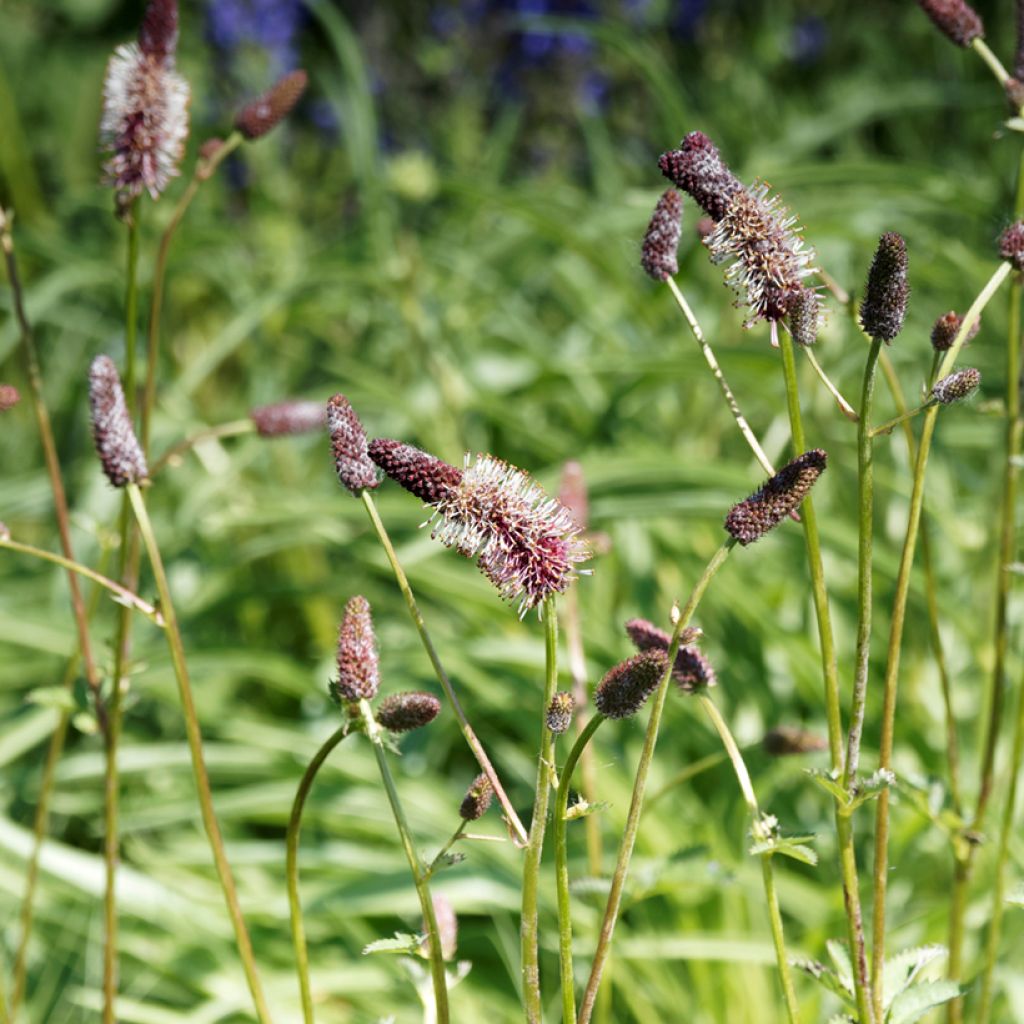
[99,0,188,207]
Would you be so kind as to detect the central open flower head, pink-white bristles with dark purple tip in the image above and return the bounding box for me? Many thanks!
[370,440,590,615]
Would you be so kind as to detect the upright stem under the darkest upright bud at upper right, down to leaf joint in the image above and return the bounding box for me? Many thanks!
[843,338,882,790]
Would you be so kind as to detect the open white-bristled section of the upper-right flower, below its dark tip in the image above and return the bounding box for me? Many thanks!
[705,182,814,327]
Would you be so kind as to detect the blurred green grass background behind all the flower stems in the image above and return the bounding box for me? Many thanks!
[0,0,1024,1024]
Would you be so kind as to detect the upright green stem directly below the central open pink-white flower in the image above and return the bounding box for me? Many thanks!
[519,596,558,1024]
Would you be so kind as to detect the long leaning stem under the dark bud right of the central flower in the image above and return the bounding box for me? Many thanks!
[579,538,736,1024]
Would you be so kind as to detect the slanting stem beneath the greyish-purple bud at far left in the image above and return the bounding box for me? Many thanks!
[126,483,270,1024]
